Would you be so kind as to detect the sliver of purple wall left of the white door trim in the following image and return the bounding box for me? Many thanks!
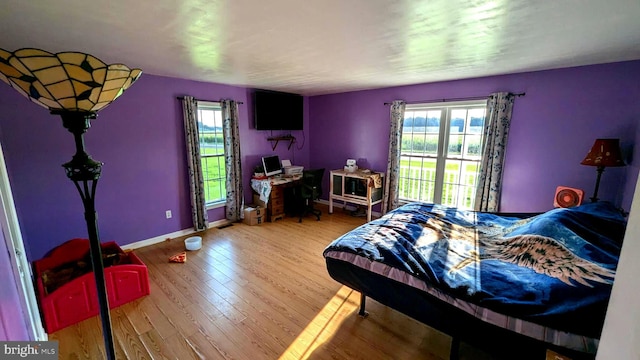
[0,229,31,341]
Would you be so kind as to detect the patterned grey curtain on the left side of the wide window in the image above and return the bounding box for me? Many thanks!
[382,100,406,214]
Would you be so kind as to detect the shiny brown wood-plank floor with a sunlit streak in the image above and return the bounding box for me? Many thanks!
[50,205,484,360]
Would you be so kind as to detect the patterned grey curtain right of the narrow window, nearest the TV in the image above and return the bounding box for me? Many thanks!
[220,100,244,221]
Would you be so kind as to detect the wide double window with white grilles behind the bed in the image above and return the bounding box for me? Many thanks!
[399,101,486,209]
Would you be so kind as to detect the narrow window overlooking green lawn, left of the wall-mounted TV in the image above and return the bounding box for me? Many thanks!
[198,101,227,207]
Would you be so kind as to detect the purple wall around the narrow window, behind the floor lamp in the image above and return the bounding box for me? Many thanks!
[0,74,309,260]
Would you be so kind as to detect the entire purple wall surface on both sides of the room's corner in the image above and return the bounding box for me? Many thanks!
[0,61,640,260]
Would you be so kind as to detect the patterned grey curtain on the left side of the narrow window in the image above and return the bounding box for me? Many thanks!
[182,96,209,231]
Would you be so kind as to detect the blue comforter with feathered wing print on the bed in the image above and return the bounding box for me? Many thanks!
[325,202,626,338]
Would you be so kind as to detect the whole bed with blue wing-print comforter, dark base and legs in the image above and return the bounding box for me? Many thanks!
[323,202,626,359]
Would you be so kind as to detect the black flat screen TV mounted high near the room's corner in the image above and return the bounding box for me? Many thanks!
[253,89,303,130]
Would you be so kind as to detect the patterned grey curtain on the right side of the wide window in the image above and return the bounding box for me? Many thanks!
[475,92,514,212]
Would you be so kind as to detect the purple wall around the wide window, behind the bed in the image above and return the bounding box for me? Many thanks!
[309,61,640,211]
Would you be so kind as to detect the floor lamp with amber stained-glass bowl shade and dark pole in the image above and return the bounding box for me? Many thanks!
[0,49,142,360]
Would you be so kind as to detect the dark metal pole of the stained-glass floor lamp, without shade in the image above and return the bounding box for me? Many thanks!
[51,110,115,360]
